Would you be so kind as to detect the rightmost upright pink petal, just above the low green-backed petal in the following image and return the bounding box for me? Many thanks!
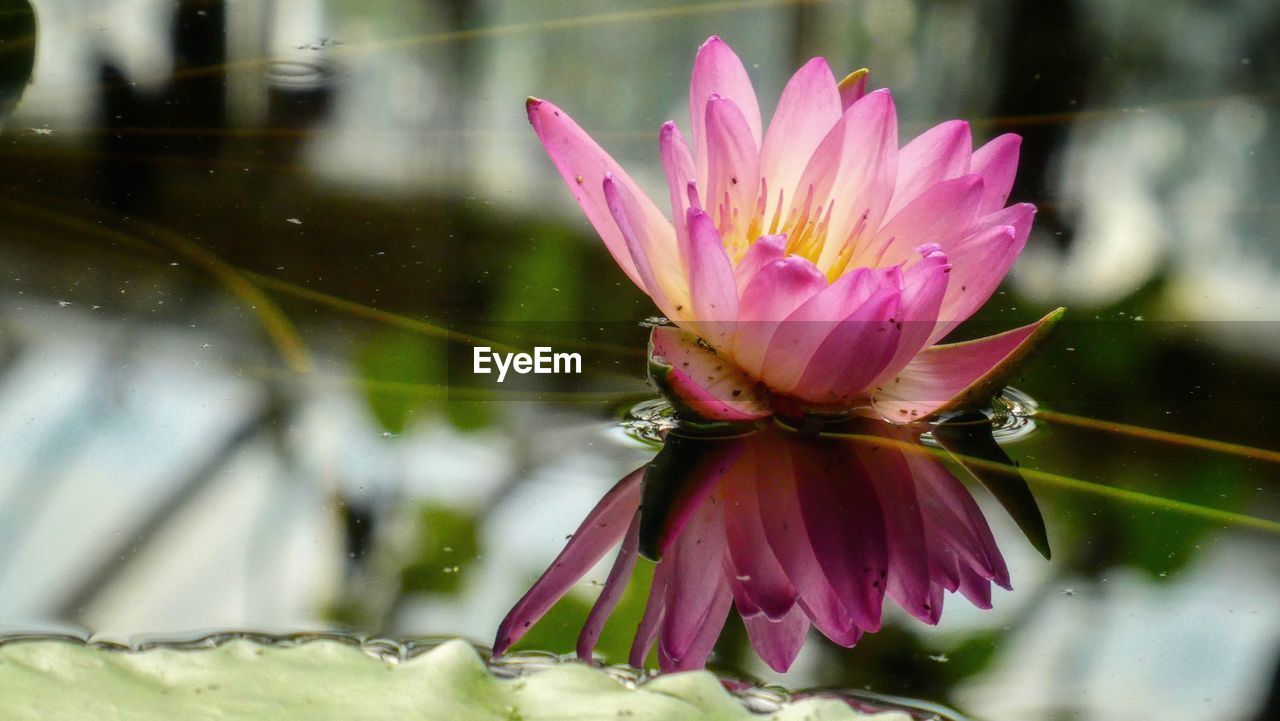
[929,202,1036,343]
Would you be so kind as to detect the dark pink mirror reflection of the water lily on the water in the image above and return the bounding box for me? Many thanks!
[494,420,1043,671]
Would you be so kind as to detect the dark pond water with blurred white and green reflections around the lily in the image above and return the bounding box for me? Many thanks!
[0,0,1280,720]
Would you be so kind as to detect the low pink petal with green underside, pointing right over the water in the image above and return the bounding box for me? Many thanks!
[873,309,1064,423]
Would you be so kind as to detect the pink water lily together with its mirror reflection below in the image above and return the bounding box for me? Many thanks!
[494,37,1062,670]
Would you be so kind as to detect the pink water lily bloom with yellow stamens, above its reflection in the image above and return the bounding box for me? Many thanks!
[527,37,1061,421]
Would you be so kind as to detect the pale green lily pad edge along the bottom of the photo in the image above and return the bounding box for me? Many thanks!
[0,640,909,721]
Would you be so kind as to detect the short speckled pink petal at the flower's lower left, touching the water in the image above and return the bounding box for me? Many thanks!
[649,325,771,423]
